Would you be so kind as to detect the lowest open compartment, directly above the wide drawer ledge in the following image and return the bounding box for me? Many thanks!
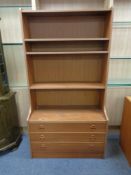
[30,89,104,109]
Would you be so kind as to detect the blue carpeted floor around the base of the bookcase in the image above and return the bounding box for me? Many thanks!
[0,135,131,175]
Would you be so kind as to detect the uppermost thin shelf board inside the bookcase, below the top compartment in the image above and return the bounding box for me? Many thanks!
[24,38,109,42]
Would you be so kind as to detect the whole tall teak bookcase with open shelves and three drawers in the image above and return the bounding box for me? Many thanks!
[21,9,112,158]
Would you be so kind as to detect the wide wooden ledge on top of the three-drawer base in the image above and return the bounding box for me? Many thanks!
[29,109,106,123]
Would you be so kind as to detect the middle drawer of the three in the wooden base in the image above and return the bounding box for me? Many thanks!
[30,132,105,142]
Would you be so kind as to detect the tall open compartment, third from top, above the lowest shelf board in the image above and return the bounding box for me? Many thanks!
[27,54,107,85]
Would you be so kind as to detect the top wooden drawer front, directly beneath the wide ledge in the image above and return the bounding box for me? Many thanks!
[29,123,107,132]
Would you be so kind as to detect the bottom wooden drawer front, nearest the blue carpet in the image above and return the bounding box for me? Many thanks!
[31,142,104,153]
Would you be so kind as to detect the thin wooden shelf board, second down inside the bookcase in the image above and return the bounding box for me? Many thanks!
[26,51,109,55]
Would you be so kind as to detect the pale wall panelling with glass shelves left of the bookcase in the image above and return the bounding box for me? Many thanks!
[0,0,31,126]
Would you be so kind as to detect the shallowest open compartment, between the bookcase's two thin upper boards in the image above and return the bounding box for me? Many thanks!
[25,38,109,55]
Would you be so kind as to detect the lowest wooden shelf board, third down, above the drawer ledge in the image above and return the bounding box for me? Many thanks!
[30,83,105,90]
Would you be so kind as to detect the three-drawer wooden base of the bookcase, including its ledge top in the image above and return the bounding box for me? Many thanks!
[28,110,107,158]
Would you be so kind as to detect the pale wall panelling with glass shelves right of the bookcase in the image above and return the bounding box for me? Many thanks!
[106,0,131,125]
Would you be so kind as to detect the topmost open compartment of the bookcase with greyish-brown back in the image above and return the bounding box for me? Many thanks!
[22,10,111,39]
